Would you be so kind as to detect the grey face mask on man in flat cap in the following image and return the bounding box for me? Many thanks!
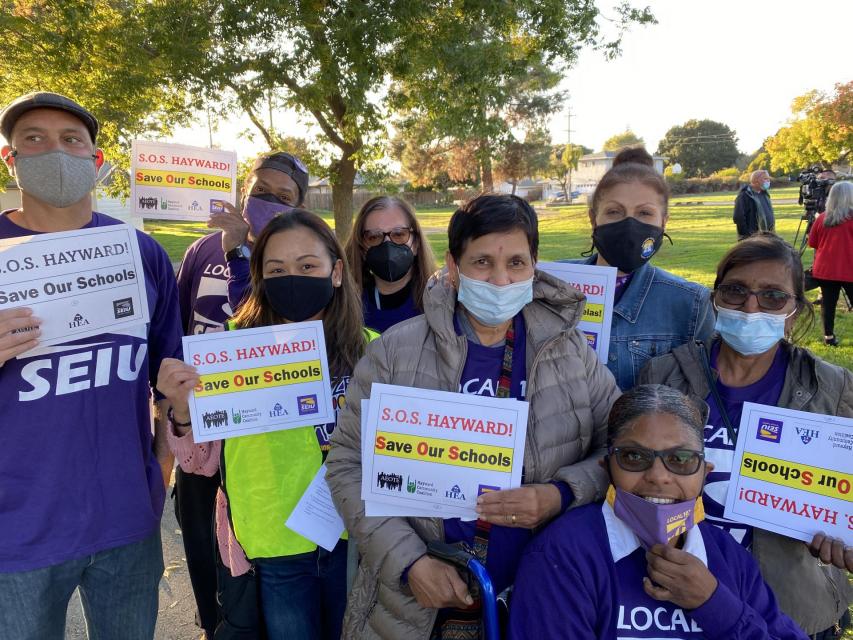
[15,151,97,209]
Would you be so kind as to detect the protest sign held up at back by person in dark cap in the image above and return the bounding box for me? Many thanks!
[130,140,237,221]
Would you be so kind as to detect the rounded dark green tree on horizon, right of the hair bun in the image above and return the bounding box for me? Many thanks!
[657,119,740,178]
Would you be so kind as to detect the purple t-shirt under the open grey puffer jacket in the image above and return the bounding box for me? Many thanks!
[444,313,533,593]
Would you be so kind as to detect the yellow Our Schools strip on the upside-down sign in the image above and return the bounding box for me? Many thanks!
[740,453,853,502]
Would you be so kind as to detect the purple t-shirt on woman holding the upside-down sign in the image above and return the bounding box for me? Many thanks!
[702,341,788,548]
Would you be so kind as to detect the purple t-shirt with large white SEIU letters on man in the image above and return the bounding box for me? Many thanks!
[0,213,181,573]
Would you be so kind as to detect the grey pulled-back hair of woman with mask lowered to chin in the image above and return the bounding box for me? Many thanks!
[607,384,708,450]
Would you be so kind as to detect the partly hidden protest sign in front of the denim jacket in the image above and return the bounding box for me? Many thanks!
[536,262,616,363]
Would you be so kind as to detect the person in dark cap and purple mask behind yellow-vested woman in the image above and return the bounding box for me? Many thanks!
[175,151,308,638]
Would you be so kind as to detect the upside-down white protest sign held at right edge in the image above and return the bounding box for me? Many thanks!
[725,402,853,545]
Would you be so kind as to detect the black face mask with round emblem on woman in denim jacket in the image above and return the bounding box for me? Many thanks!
[592,218,663,273]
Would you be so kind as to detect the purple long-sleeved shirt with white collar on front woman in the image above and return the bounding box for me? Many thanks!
[510,503,807,640]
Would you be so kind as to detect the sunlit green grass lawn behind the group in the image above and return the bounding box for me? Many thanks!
[145,187,853,369]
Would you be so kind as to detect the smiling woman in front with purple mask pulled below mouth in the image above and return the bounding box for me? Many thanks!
[509,385,806,640]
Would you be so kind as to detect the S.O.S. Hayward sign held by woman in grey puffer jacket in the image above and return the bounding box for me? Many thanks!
[361,384,528,518]
